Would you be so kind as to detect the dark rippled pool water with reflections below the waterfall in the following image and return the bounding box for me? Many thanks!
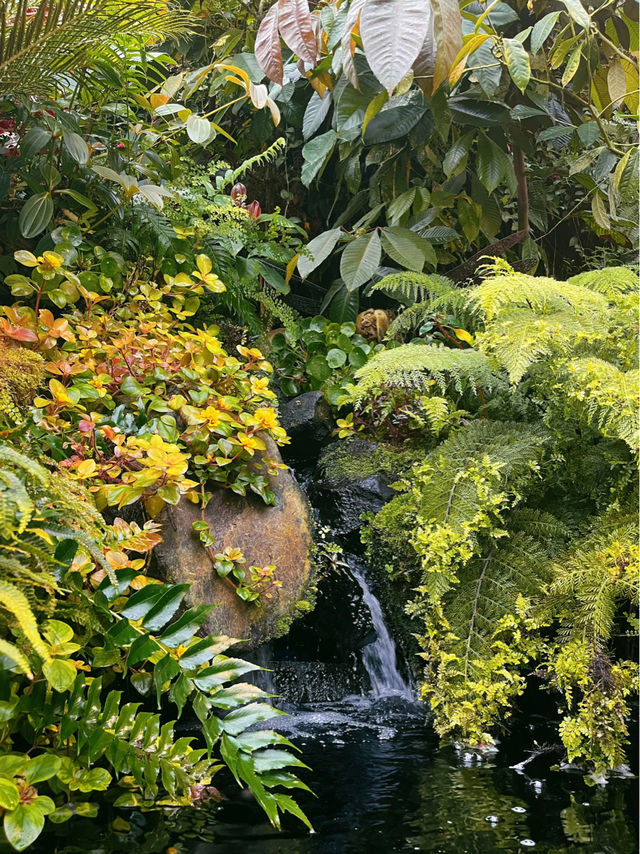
[40,697,638,854]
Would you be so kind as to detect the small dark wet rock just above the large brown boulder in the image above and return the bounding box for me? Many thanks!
[280,391,333,461]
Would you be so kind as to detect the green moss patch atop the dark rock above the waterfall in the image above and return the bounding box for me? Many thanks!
[319,437,428,487]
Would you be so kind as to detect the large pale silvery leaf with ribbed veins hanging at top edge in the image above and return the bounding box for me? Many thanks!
[360,0,430,97]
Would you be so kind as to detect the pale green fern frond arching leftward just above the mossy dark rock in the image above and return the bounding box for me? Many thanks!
[352,344,495,404]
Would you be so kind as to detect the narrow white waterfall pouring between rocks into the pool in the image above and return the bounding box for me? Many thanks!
[350,562,412,698]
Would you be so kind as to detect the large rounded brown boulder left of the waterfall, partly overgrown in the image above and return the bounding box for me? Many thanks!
[154,439,313,646]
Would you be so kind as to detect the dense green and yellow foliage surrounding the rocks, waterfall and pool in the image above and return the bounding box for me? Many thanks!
[0,0,638,850]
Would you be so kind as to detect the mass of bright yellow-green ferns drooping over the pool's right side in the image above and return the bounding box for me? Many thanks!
[362,262,638,778]
